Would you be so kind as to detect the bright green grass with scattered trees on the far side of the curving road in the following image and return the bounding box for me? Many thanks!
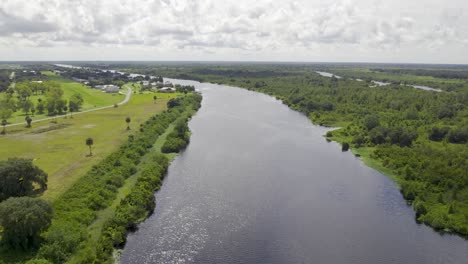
[8,72,125,124]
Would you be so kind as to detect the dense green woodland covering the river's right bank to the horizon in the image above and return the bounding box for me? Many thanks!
[116,65,468,235]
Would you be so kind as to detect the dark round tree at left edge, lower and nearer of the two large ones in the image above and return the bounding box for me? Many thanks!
[0,197,53,249]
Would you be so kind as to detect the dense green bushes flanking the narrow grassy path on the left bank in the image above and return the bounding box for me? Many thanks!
[22,93,201,263]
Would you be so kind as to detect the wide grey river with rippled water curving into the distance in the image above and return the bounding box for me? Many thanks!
[121,81,468,264]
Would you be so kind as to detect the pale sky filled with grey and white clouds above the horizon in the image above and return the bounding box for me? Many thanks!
[0,0,468,64]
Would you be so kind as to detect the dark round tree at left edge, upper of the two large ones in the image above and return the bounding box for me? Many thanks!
[0,158,47,202]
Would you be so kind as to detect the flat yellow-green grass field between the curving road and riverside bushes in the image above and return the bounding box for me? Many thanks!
[0,93,177,200]
